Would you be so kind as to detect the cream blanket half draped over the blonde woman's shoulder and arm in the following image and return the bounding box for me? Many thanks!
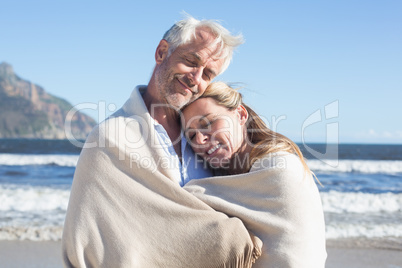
[184,153,327,268]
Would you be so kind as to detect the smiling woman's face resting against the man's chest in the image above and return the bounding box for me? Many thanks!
[182,97,247,168]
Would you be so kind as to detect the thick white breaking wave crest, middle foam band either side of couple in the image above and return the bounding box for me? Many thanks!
[0,185,402,213]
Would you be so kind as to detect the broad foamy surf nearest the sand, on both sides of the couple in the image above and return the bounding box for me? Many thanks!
[0,185,402,241]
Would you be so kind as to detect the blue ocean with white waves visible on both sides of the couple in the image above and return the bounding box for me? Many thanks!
[0,139,402,250]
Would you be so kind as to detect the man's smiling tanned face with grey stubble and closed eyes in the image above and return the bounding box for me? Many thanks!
[157,30,224,109]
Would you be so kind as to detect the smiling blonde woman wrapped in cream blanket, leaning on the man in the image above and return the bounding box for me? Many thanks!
[182,82,327,268]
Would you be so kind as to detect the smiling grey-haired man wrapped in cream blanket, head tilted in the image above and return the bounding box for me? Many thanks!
[62,17,261,267]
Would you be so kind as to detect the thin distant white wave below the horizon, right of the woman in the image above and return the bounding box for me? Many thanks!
[307,160,402,174]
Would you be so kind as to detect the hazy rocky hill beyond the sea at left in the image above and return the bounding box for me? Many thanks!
[0,62,96,139]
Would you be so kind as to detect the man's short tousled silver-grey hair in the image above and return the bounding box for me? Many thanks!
[163,14,244,73]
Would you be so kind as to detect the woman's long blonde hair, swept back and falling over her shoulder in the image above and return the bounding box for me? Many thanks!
[200,82,314,175]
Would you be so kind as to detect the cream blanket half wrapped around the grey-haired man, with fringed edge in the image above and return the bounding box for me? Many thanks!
[62,88,261,268]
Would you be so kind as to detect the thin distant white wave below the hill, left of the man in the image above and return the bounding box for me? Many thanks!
[0,154,79,167]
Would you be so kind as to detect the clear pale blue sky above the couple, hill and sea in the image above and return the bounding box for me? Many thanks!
[0,0,402,144]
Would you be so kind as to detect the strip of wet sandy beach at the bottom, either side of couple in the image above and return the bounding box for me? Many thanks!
[0,241,402,268]
